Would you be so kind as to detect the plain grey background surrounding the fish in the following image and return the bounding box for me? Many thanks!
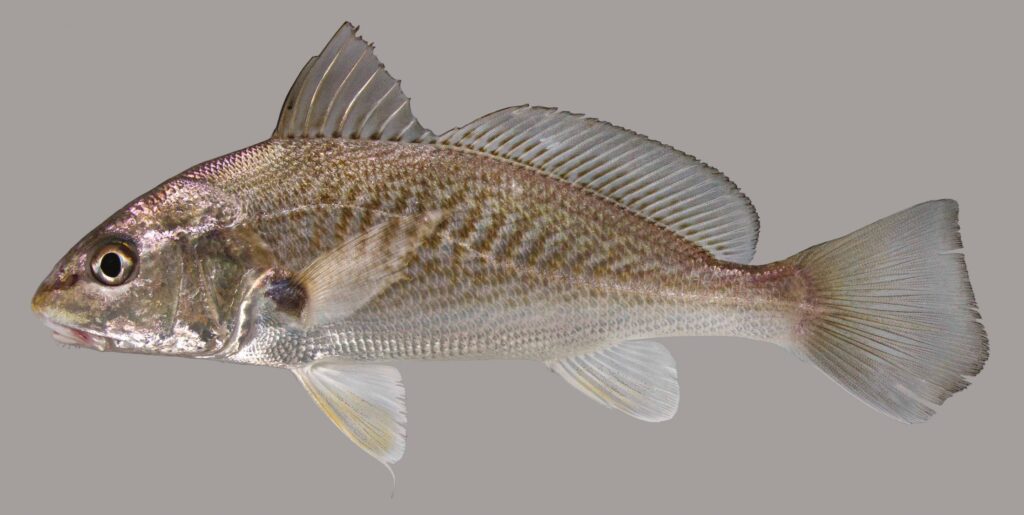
[0,0,1024,514]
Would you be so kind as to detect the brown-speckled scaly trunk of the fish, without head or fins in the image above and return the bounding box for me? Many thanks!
[178,139,799,367]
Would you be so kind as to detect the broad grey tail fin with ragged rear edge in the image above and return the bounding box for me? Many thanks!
[786,200,988,423]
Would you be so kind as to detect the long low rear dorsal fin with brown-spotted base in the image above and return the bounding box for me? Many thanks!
[437,105,758,263]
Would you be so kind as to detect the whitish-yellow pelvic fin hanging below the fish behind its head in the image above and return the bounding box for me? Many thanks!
[292,359,406,468]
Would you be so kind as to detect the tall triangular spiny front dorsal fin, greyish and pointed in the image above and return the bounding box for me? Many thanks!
[273,22,435,142]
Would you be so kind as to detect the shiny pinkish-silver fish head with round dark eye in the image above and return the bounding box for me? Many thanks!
[32,180,256,357]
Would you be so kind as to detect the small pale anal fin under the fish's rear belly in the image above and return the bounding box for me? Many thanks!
[547,341,679,422]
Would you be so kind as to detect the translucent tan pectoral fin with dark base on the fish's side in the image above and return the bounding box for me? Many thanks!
[266,212,441,326]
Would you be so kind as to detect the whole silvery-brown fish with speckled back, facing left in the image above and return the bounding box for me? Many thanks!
[32,23,988,469]
